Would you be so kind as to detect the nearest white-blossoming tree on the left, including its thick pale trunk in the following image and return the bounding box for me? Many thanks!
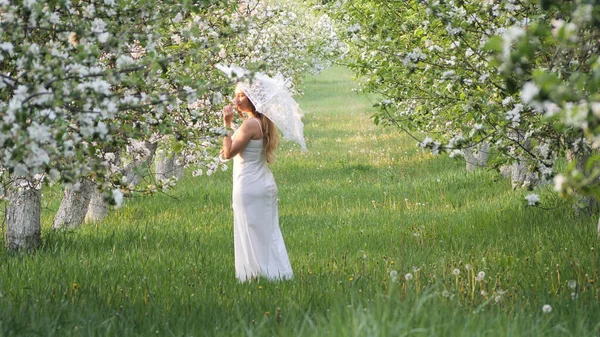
[0,0,237,249]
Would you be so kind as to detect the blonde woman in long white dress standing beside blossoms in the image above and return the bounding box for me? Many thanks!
[221,84,293,282]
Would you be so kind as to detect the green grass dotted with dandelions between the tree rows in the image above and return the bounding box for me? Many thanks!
[0,68,600,336]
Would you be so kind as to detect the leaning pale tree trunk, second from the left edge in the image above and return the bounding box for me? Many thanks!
[52,179,94,229]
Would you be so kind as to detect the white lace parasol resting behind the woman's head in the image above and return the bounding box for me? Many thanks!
[216,64,306,151]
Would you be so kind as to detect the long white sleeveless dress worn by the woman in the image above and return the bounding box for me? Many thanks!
[233,119,293,282]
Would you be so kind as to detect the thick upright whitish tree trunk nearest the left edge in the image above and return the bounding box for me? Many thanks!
[6,179,42,251]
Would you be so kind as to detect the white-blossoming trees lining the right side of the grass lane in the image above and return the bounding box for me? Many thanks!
[338,0,599,228]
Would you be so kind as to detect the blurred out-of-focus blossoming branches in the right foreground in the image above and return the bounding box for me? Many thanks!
[491,0,600,233]
